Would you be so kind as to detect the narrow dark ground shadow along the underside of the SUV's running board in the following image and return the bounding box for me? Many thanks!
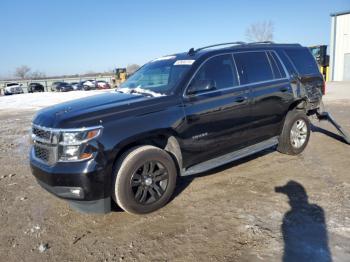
[169,147,276,202]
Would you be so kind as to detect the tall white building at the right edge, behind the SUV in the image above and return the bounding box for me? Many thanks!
[329,10,350,81]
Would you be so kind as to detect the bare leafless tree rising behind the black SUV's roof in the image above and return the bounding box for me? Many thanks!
[245,21,274,42]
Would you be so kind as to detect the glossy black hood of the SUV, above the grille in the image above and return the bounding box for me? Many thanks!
[33,92,151,128]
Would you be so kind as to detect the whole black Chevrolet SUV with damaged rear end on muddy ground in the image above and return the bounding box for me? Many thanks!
[30,42,324,214]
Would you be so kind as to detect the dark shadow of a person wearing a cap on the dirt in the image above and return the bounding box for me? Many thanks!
[275,181,332,262]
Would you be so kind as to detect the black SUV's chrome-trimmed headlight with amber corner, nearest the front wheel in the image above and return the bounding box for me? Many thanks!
[58,128,101,161]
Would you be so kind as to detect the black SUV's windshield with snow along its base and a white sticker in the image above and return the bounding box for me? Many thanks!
[118,56,193,95]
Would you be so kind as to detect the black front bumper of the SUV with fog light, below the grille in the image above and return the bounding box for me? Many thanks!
[30,147,112,213]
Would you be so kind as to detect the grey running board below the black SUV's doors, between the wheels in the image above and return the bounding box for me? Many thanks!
[181,136,278,176]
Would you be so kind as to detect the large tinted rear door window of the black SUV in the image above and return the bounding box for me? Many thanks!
[234,52,274,84]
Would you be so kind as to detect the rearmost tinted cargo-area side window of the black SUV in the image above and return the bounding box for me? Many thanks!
[285,48,319,75]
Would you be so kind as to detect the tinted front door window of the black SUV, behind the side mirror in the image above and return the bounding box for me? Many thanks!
[191,55,238,89]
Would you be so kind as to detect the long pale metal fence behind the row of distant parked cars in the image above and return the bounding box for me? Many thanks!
[0,76,113,95]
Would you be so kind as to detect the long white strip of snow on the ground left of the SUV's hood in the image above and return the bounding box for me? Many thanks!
[0,89,114,112]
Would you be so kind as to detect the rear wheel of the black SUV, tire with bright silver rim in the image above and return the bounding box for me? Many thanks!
[277,110,310,155]
